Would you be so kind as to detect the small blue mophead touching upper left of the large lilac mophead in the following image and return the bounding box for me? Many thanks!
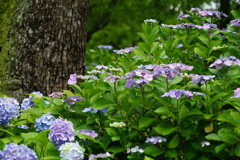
[35,113,56,131]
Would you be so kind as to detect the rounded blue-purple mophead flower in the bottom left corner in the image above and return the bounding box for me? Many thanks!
[0,143,37,160]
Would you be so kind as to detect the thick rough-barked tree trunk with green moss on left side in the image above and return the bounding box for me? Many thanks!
[4,0,88,97]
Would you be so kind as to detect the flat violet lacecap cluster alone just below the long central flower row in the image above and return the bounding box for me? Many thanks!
[162,89,193,99]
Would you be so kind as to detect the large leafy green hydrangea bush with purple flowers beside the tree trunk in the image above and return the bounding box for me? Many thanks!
[0,1,240,160]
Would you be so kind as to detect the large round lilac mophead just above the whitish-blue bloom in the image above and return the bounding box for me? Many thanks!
[48,118,75,148]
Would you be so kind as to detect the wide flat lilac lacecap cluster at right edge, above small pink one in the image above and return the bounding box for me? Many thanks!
[210,56,240,70]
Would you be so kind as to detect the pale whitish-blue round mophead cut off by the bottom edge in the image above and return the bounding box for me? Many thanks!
[59,142,84,160]
